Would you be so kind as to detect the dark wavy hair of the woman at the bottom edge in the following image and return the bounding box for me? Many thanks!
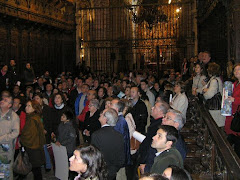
[76,145,107,180]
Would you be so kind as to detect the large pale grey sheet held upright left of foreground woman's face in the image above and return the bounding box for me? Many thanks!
[52,143,69,180]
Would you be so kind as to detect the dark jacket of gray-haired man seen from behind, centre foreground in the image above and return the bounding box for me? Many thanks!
[91,126,125,179]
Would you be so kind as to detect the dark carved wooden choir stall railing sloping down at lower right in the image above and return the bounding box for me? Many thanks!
[188,98,240,180]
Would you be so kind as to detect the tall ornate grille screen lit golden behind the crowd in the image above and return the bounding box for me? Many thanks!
[76,0,194,72]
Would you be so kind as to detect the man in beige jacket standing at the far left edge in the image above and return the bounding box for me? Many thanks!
[0,97,20,179]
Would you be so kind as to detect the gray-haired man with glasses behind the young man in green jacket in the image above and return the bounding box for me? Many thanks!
[140,109,187,173]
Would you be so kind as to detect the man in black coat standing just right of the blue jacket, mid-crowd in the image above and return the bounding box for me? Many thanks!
[130,87,148,134]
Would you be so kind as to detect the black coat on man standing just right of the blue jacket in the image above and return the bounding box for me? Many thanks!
[130,99,148,134]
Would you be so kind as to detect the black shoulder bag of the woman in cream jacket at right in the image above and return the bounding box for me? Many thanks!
[206,79,222,110]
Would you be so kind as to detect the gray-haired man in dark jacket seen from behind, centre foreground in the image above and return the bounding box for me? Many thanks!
[91,108,125,180]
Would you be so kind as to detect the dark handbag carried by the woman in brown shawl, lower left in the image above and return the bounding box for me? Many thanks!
[13,150,32,175]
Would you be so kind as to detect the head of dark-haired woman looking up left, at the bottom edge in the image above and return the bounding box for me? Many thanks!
[69,145,107,180]
